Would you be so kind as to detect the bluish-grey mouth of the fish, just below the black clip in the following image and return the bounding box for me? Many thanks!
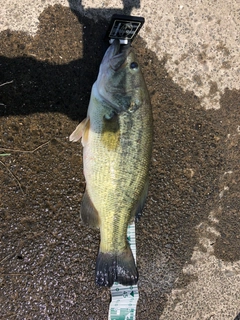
[103,39,131,71]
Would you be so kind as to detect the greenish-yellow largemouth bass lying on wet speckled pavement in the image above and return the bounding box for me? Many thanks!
[70,40,152,287]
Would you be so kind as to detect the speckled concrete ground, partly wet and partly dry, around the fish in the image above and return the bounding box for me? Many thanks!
[0,0,240,320]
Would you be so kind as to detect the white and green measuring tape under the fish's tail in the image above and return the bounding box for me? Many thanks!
[108,223,139,320]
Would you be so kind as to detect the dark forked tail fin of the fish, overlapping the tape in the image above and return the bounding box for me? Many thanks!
[96,243,138,287]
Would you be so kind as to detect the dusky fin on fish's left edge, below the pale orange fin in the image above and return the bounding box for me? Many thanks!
[80,190,99,228]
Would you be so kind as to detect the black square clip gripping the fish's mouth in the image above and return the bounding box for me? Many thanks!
[106,14,145,44]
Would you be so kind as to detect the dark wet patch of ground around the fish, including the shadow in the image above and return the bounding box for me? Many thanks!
[0,2,240,320]
